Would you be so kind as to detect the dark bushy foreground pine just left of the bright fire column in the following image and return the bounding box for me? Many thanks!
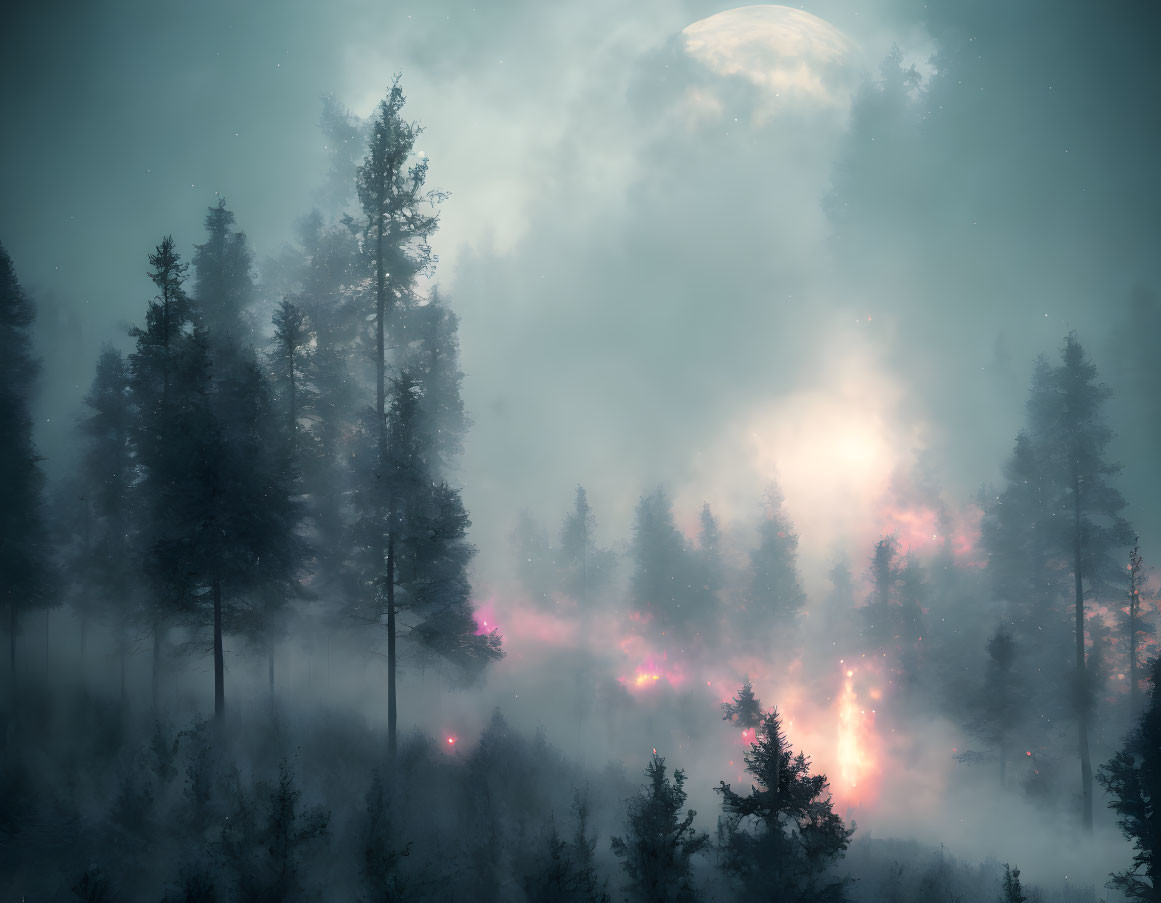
[716,709,854,903]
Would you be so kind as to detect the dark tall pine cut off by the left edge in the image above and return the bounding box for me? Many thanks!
[0,245,50,688]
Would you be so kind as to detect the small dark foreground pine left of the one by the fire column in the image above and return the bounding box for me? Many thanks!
[612,754,709,903]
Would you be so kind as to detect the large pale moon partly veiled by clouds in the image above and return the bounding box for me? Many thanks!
[682,5,859,110]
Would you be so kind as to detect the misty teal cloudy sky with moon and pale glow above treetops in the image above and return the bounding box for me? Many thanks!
[0,0,1161,584]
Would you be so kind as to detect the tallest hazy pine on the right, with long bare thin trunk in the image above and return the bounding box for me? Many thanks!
[1027,334,1132,830]
